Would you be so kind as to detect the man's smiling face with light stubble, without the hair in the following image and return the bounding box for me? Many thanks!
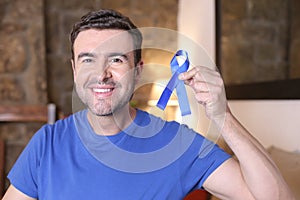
[72,29,142,116]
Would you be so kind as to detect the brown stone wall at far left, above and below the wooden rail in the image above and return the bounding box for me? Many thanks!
[0,0,48,189]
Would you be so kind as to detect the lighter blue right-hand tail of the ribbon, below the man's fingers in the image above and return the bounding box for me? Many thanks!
[176,80,191,116]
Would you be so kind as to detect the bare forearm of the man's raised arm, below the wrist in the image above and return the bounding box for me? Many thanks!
[219,111,293,199]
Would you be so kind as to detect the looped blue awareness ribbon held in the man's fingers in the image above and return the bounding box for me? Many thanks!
[156,50,191,116]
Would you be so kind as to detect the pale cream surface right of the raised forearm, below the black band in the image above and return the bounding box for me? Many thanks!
[229,100,300,151]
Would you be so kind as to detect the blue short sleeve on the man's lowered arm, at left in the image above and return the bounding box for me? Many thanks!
[7,127,45,198]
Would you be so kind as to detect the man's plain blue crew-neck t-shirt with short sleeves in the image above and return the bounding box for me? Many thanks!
[8,110,230,200]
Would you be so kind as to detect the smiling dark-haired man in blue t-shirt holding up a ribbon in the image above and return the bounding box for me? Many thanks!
[4,10,293,200]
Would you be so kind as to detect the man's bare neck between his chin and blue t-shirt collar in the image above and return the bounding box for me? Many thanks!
[87,106,136,136]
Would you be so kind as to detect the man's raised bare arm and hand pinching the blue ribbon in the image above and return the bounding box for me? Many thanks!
[179,67,294,200]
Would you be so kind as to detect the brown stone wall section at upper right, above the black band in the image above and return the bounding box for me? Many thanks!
[221,0,300,84]
